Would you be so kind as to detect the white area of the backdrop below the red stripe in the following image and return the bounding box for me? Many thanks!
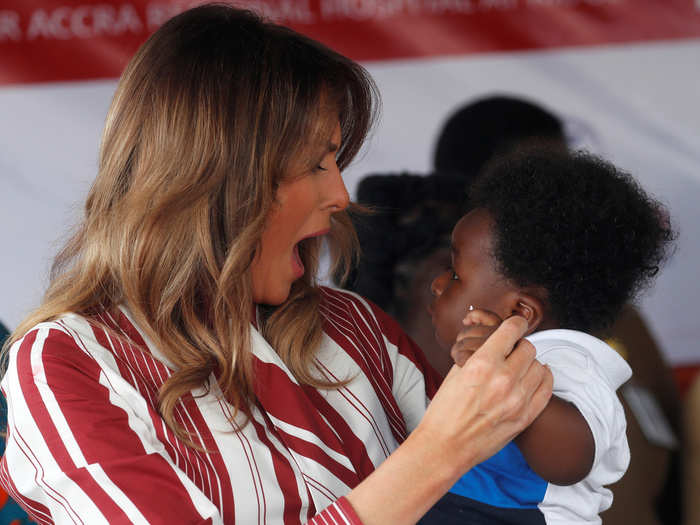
[0,8,700,365]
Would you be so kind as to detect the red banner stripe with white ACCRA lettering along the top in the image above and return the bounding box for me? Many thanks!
[0,0,700,85]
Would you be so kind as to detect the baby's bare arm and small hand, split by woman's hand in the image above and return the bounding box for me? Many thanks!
[451,310,595,485]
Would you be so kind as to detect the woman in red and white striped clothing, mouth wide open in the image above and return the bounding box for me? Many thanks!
[0,6,551,524]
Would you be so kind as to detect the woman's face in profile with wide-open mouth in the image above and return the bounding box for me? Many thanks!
[251,124,349,305]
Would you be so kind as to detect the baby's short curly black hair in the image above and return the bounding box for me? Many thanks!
[470,148,675,332]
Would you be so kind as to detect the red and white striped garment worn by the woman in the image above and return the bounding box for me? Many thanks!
[0,288,435,525]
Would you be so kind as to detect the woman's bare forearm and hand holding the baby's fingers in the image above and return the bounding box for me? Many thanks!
[347,317,552,525]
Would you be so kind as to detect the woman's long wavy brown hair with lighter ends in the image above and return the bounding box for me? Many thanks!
[5,5,378,439]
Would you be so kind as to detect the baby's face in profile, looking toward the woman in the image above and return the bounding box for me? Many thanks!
[428,209,517,351]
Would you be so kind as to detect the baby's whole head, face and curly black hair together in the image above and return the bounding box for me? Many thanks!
[430,149,674,348]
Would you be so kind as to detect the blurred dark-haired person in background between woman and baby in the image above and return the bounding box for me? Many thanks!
[336,173,467,375]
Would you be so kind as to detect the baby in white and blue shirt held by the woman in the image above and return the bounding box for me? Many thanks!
[420,149,673,525]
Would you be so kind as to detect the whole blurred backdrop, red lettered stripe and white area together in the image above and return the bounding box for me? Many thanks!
[0,0,700,519]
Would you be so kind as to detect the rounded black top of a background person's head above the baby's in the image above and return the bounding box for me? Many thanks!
[433,95,566,180]
